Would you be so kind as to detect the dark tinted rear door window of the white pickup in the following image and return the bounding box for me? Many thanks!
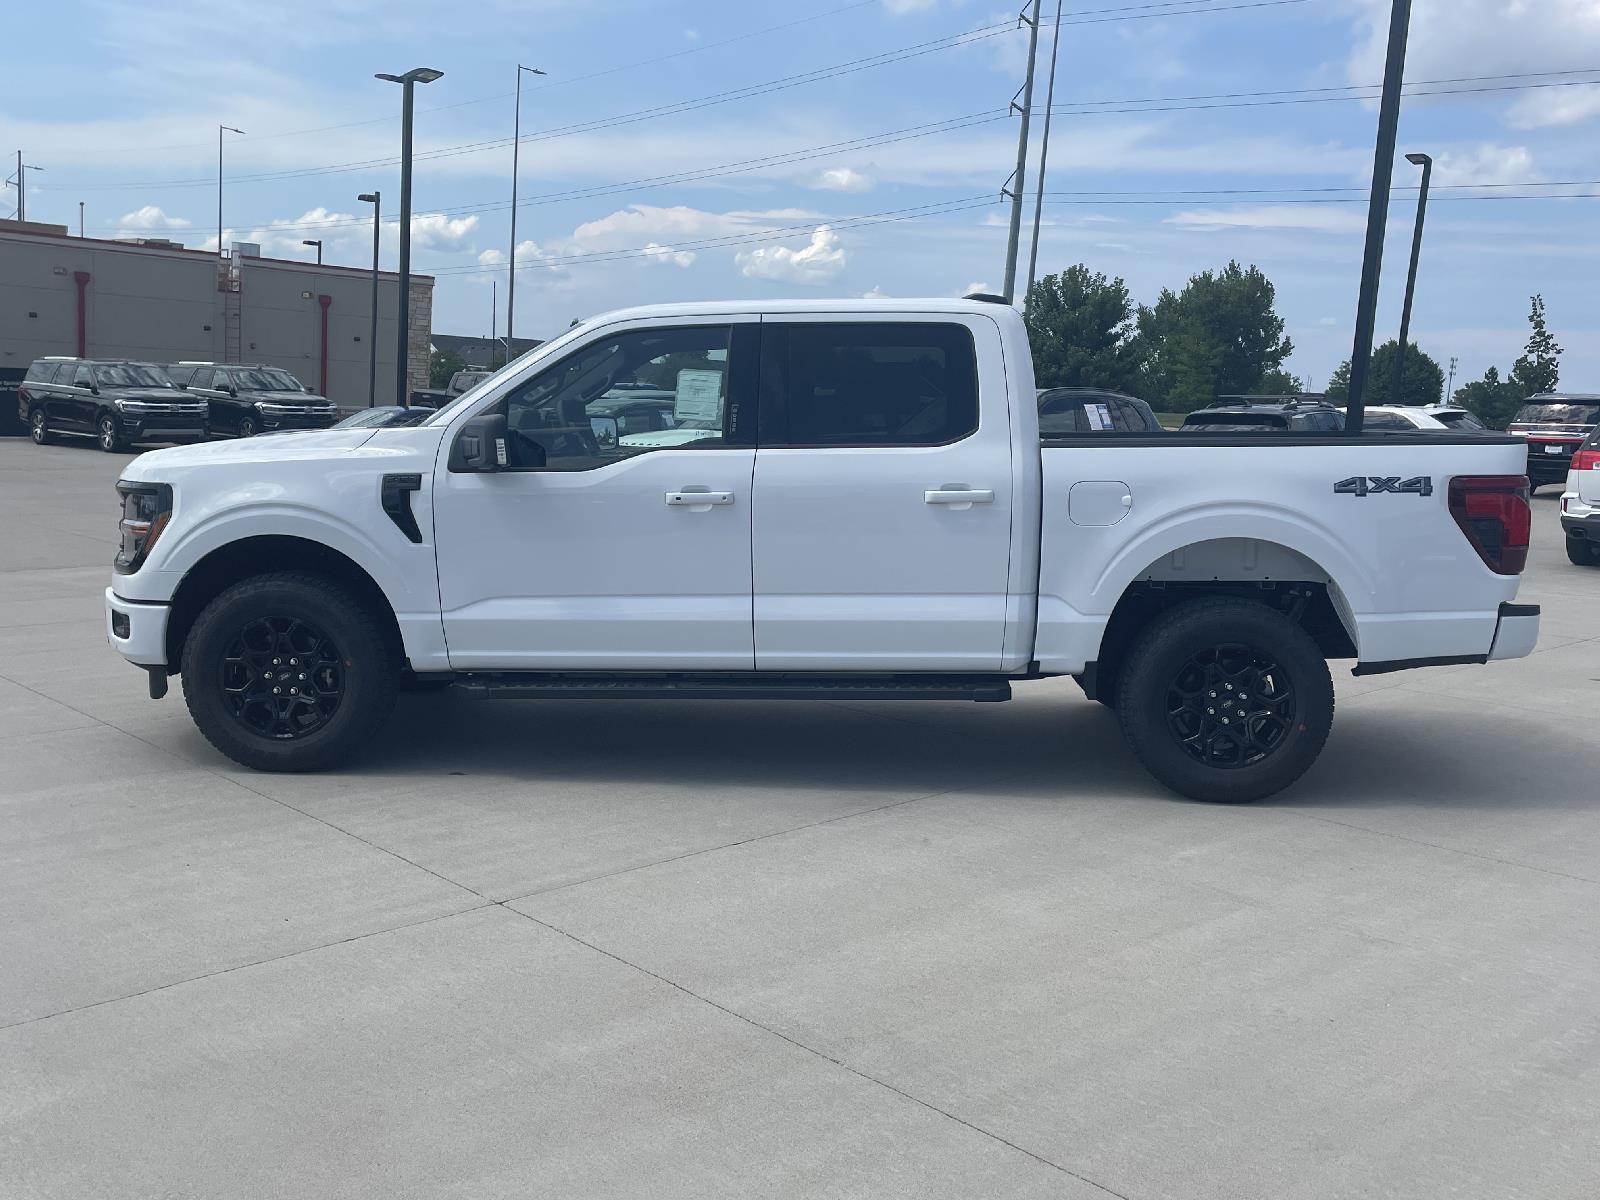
[762,322,978,446]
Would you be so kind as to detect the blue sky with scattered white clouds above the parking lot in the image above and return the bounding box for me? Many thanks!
[0,0,1600,390]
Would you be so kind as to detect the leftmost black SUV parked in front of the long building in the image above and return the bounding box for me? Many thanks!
[16,358,206,451]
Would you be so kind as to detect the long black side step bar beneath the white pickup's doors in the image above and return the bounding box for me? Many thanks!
[454,670,1011,704]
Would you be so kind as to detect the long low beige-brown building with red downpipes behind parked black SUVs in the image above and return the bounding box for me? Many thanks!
[0,221,434,408]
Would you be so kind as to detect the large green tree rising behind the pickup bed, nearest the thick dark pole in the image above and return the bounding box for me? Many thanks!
[1139,262,1294,413]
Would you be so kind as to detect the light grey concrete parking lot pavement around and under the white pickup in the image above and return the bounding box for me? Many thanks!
[0,440,1600,1200]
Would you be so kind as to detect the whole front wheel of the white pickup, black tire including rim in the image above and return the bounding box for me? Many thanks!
[182,571,400,771]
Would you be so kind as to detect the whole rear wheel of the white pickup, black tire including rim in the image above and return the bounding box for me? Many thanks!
[1117,597,1333,803]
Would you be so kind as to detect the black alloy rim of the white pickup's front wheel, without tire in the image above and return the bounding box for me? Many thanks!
[221,616,344,741]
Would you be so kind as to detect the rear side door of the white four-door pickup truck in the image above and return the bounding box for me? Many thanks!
[752,315,1013,670]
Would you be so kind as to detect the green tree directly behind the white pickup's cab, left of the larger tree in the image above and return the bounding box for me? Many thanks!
[1022,262,1141,392]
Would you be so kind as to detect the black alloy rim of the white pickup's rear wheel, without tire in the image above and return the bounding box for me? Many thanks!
[1166,642,1298,770]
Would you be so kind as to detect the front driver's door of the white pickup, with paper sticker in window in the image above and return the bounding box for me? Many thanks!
[434,320,757,670]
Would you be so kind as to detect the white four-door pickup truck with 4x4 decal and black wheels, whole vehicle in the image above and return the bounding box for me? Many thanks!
[106,299,1539,800]
